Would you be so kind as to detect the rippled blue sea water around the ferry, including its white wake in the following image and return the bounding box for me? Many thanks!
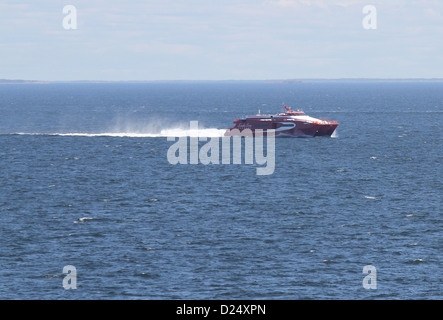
[0,81,443,300]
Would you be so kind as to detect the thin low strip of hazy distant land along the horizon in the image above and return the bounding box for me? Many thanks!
[0,78,443,84]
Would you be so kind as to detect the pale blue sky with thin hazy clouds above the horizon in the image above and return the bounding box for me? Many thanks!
[0,0,443,81]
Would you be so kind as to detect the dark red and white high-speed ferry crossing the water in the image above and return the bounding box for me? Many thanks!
[225,106,338,137]
